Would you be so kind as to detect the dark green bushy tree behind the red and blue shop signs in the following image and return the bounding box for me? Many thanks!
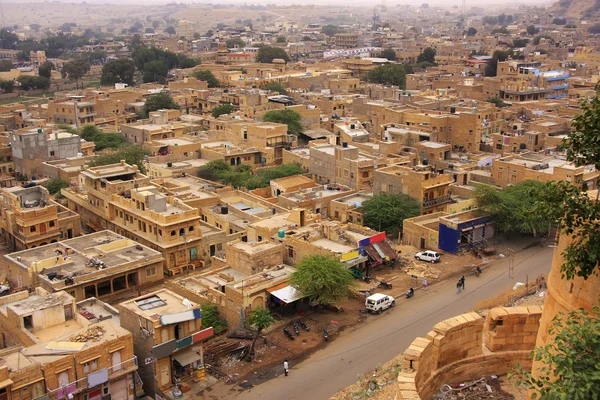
[362,193,421,236]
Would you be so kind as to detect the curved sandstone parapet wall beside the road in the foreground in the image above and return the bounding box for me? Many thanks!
[398,306,542,400]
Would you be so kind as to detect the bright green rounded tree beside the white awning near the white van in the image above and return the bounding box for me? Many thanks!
[290,254,355,305]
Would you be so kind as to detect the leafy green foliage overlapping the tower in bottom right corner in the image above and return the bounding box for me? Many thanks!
[510,305,600,400]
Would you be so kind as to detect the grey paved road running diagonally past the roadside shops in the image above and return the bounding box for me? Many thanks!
[227,247,553,400]
